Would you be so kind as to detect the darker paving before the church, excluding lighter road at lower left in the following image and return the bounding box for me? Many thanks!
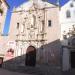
[0,64,75,75]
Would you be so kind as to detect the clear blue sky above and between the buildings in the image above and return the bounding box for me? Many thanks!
[3,0,69,35]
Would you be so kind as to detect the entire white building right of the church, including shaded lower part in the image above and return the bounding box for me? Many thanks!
[60,0,75,71]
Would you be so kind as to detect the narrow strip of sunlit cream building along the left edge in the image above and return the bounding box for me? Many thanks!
[0,0,9,55]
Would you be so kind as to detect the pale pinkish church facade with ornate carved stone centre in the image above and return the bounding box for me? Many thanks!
[4,0,61,65]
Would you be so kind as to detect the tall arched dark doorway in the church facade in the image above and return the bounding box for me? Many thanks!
[25,46,36,66]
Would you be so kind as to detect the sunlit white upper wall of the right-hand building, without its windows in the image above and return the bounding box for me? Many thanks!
[59,0,75,40]
